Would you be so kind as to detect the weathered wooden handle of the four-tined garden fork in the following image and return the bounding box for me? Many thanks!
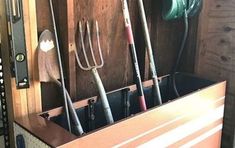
[92,68,114,124]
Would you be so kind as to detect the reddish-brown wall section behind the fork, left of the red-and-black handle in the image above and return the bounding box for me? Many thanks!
[54,0,132,98]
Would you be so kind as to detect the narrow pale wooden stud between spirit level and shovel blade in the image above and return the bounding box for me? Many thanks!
[23,0,42,113]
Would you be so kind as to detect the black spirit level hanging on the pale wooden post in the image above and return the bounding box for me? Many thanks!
[6,0,29,89]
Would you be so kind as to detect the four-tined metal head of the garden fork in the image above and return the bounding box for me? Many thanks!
[75,21,104,70]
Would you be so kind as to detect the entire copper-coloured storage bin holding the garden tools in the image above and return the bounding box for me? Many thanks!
[14,73,226,148]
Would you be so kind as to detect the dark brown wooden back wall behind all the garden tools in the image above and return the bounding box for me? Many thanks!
[37,0,198,109]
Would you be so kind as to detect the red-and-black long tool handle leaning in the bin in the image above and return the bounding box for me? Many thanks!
[121,0,147,111]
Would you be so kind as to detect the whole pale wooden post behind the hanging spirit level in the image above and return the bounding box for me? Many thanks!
[2,0,41,118]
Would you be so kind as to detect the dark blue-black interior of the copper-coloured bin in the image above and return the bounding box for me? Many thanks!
[50,73,215,133]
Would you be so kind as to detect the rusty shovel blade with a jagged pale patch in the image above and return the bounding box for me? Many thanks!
[38,30,60,82]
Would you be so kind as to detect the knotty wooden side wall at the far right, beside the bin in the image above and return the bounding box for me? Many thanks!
[196,0,235,147]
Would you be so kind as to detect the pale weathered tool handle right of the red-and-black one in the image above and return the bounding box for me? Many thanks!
[138,0,162,105]
